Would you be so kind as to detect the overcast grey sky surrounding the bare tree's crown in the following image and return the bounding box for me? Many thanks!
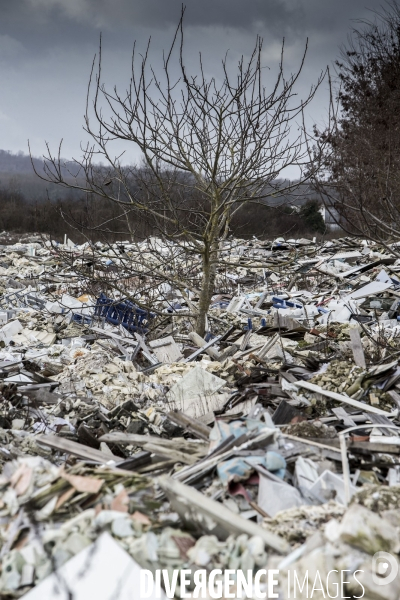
[0,0,381,165]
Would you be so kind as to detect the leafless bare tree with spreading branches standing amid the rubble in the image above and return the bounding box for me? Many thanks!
[32,11,323,335]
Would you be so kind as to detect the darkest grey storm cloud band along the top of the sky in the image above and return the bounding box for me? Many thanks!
[0,0,379,46]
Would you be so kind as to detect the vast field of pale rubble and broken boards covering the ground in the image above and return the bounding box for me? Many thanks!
[0,236,400,600]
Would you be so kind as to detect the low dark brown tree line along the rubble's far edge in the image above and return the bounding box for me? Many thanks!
[0,177,325,243]
